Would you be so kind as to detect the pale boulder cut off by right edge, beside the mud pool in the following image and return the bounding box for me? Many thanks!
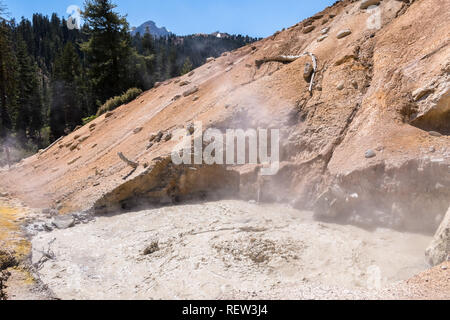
[425,208,450,266]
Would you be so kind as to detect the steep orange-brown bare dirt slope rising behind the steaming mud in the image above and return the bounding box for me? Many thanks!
[0,0,450,232]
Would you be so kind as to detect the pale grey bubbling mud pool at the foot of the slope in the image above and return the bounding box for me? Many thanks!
[32,200,431,299]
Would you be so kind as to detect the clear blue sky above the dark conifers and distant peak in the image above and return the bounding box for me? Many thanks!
[0,0,336,37]
